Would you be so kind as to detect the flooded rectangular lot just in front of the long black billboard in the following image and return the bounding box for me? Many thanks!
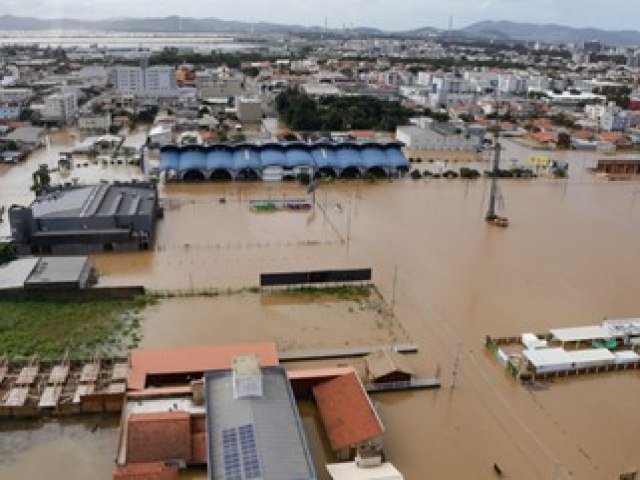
[142,292,410,352]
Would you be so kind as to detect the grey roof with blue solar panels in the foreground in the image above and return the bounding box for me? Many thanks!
[205,367,316,480]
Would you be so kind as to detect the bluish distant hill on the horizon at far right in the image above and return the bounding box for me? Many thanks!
[462,20,640,46]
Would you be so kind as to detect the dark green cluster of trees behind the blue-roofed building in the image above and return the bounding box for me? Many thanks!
[276,88,412,131]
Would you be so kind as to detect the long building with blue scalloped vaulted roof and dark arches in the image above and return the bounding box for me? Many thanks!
[160,142,409,181]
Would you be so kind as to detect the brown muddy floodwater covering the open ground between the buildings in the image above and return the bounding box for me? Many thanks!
[0,136,640,480]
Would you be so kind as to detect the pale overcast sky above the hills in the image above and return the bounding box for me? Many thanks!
[0,0,640,30]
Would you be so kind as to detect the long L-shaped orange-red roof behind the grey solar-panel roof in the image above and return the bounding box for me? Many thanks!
[127,342,279,390]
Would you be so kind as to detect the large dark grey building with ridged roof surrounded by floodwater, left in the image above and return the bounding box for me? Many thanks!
[9,183,160,254]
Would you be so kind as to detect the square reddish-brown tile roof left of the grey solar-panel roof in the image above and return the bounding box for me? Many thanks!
[127,412,191,463]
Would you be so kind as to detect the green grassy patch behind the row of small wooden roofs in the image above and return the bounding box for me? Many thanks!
[0,298,147,358]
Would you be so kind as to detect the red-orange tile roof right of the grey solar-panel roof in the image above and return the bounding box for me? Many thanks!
[313,373,384,450]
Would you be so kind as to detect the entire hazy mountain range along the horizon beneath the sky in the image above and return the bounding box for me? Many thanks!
[0,15,640,46]
